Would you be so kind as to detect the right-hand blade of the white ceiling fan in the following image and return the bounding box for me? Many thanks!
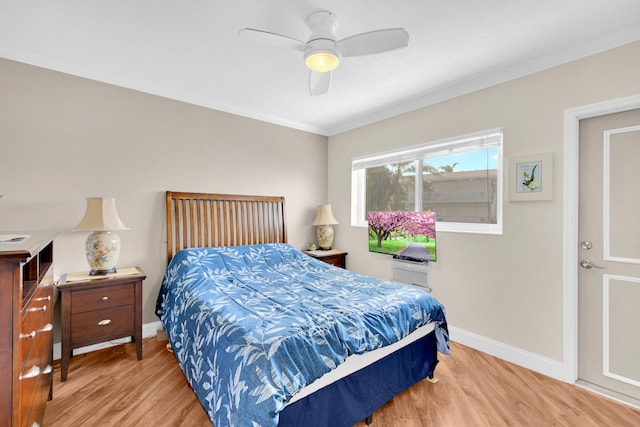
[338,28,409,57]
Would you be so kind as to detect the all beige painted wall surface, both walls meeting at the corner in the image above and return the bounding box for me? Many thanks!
[0,43,640,366]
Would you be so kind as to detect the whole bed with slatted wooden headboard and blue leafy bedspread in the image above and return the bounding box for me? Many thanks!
[156,191,449,427]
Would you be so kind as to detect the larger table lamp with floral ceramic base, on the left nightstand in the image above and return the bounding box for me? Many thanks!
[74,197,129,276]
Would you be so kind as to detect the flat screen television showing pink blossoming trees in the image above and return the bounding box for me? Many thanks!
[367,211,436,262]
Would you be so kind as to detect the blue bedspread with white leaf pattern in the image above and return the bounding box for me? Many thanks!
[156,243,449,427]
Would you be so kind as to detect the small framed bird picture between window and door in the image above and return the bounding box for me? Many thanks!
[509,153,553,202]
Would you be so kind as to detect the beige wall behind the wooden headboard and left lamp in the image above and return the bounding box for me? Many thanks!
[0,60,327,323]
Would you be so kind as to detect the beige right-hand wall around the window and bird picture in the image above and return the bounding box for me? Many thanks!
[329,43,640,361]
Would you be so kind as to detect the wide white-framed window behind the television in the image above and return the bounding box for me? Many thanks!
[351,129,502,234]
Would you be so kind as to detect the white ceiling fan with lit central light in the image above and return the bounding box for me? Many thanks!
[238,10,409,95]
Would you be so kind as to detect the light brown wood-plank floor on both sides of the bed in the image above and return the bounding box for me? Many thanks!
[44,338,640,427]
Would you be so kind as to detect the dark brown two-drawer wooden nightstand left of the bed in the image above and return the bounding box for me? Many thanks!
[58,267,147,381]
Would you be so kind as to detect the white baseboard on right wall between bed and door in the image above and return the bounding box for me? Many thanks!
[449,325,565,382]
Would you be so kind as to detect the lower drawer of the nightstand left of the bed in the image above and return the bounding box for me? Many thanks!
[71,304,135,342]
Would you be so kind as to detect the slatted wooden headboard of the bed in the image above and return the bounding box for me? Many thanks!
[167,191,287,262]
